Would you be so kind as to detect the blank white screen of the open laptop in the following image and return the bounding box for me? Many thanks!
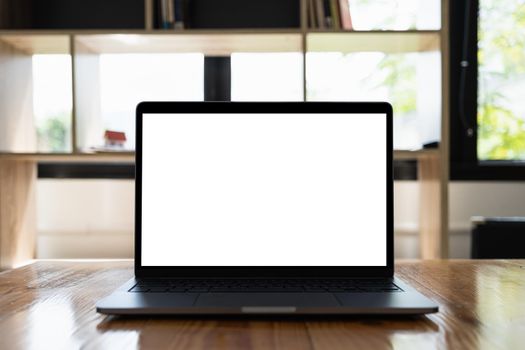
[141,113,387,266]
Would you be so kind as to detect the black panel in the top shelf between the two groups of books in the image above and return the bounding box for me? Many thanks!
[184,0,301,29]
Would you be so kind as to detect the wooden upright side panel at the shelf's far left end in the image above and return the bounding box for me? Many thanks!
[0,25,36,269]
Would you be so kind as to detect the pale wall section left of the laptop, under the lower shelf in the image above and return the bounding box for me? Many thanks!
[37,179,134,258]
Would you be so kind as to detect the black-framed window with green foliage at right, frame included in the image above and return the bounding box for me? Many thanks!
[450,0,525,180]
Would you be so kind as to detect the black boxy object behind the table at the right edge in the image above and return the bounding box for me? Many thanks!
[471,217,525,259]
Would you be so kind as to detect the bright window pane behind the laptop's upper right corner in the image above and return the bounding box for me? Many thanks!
[306,51,441,149]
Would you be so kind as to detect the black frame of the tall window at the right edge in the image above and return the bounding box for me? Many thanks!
[449,0,525,181]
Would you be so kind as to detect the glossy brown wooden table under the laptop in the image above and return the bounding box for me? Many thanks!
[0,260,525,349]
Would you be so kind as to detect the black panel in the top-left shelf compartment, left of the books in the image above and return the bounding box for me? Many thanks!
[0,0,145,29]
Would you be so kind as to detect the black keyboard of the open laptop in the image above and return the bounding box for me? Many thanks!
[129,279,403,293]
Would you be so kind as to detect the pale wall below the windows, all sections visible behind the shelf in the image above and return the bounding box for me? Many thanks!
[37,179,525,258]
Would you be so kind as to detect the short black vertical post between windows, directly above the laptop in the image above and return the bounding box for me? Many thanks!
[204,57,231,101]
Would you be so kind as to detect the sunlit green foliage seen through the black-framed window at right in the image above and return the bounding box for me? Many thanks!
[477,0,525,160]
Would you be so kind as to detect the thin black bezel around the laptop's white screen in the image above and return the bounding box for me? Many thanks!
[135,102,394,278]
